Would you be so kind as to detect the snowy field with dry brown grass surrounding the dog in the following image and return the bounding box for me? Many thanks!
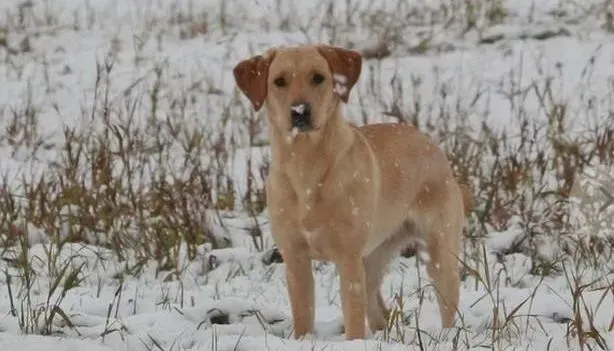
[0,0,614,351]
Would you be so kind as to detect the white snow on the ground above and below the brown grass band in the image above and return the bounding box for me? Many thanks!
[0,0,614,351]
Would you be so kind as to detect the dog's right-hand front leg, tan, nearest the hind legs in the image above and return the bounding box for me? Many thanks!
[338,254,366,340]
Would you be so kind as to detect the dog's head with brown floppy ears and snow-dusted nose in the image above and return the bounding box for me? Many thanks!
[233,45,362,132]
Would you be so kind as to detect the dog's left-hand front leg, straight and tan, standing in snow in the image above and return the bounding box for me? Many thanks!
[284,250,315,338]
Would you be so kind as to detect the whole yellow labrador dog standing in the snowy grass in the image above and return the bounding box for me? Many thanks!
[233,45,472,339]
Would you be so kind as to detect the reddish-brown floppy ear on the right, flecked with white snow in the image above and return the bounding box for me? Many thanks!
[318,45,362,102]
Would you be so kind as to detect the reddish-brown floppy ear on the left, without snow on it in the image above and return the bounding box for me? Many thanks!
[232,51,275,111]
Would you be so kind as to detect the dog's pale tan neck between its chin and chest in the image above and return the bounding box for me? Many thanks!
[268,106,355,197]
